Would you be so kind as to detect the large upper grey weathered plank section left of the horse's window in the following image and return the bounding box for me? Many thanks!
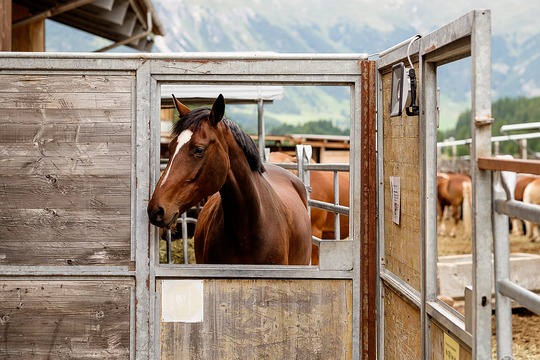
[0,74,134,265]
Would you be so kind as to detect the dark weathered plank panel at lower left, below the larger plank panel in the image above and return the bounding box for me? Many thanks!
[0,280,133,359]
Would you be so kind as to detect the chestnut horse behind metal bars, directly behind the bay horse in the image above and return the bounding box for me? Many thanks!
[269,151,349,265]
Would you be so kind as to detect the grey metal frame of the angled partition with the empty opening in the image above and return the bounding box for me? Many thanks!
[377,10,493,359]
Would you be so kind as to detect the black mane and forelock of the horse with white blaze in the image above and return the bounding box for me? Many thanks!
[172,108,265,173]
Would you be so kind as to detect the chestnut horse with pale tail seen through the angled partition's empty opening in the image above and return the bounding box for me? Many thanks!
[437,173,472,237]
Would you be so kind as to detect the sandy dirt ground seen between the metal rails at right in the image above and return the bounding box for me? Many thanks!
[438,221,540,360]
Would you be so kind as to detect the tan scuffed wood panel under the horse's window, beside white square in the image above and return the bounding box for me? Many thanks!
[158,279,352,360]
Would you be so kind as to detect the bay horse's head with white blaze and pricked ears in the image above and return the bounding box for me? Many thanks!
[147,95,229,228]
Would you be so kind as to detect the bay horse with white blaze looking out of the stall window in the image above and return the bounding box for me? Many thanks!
[147,95,312,265]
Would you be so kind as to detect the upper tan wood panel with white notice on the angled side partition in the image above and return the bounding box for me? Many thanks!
[382,69,422,292]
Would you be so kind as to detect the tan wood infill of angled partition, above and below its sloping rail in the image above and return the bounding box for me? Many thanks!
[381,67,422,359]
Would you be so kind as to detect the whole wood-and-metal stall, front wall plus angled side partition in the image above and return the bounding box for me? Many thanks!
[0,10,529,359]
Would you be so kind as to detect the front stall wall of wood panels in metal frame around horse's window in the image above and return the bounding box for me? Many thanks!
[0,53,376,359]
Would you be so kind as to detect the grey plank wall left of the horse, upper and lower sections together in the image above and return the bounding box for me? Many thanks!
[0,71,135,359]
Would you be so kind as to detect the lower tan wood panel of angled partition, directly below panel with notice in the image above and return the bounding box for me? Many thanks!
[381,286,422,360]
